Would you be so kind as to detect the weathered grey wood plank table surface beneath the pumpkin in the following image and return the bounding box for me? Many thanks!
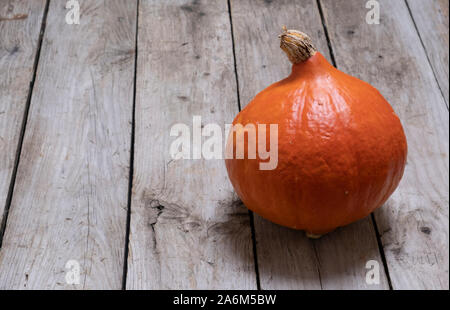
[0,0,449,290]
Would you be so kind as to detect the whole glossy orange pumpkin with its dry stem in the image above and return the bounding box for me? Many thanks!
[225,28,407,237]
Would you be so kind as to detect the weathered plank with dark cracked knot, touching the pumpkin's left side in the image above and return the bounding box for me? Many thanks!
[127,0,256,289]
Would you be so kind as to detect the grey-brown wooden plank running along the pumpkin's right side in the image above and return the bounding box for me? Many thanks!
[322,0,449,289]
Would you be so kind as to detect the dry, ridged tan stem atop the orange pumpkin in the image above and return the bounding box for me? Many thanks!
[279,26,317,64]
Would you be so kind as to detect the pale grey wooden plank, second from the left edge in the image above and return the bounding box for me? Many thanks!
[0,0,137,289]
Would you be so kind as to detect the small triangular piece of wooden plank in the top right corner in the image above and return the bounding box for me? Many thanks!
[407,0,449,106]
